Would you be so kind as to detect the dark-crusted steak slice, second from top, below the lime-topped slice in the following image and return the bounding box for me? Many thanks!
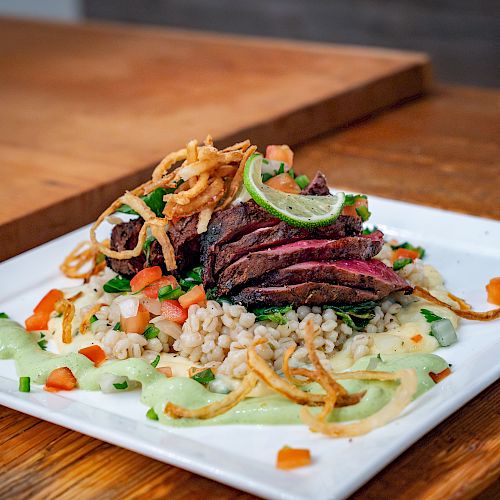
[212,215,362,276]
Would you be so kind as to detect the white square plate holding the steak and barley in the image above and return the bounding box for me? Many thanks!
[0,197,500,499]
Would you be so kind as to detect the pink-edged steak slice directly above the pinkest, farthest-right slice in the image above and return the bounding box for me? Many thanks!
[217,231,384,295]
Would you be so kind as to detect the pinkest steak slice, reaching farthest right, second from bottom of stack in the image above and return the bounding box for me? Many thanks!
[259,259,412,295]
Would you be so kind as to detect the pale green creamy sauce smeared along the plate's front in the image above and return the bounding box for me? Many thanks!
[0,319,448,426]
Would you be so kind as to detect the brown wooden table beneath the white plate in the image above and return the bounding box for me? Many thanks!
[0,18,500,499]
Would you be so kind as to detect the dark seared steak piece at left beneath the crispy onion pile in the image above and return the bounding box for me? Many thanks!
[106,215,200,278]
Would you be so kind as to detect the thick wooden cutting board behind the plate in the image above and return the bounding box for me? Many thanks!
[0,19,430,260]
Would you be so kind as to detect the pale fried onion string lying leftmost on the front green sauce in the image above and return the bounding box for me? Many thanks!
[165,373,257,420]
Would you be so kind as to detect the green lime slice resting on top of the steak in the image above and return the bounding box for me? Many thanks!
[243,154,345,228]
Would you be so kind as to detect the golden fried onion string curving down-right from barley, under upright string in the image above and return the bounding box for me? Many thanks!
[247,339,362,406]
